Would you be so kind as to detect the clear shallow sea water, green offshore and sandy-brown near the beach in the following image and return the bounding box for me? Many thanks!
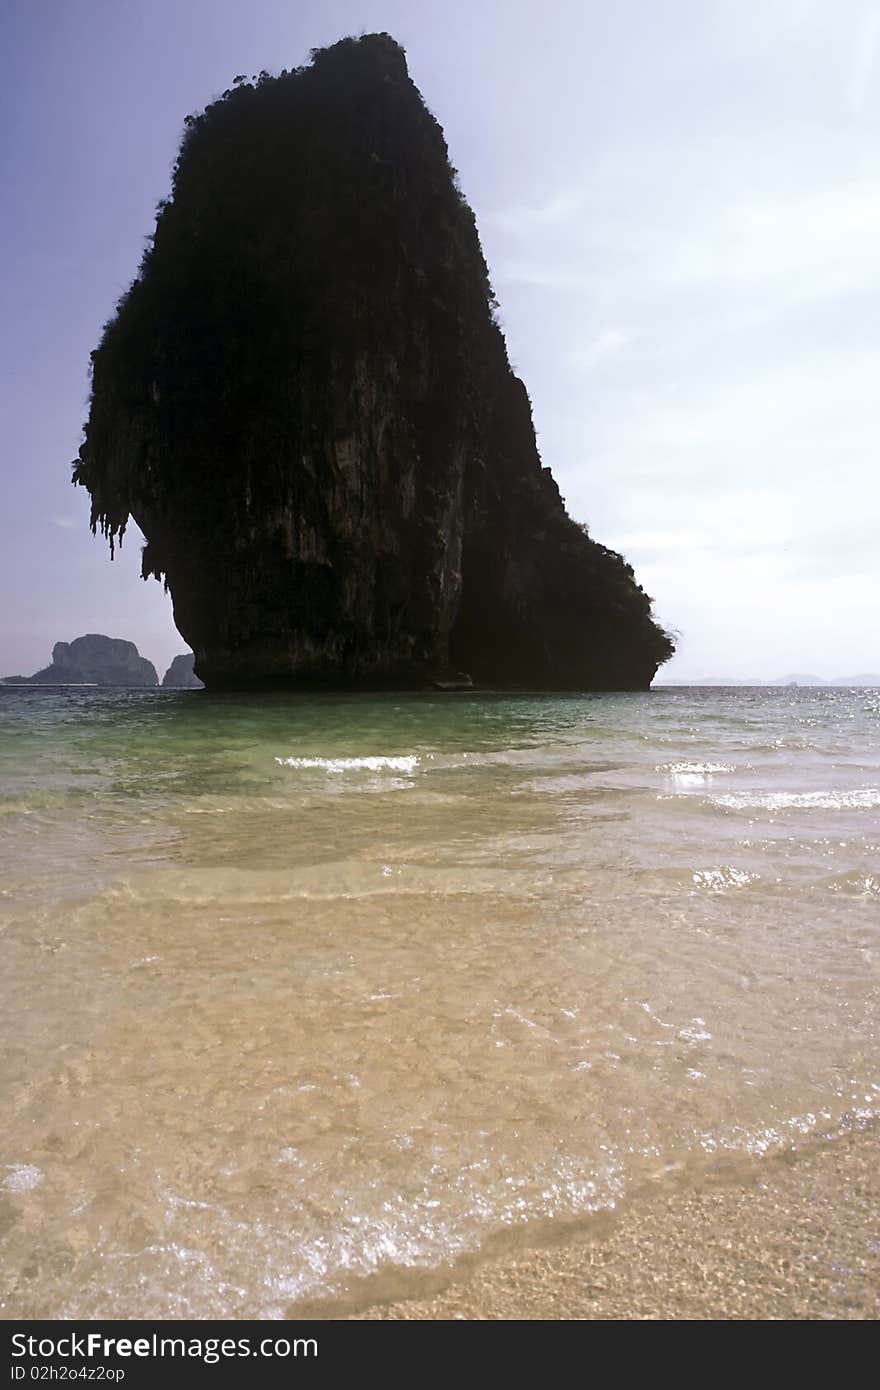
[0,688,880,1316]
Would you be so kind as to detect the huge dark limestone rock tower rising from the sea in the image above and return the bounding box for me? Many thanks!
[74,35,671,688]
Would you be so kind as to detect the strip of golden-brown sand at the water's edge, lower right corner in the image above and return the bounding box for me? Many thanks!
[359,1127,880,1321]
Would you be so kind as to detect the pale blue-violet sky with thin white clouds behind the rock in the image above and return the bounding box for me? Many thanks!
[0,0,880,678]
